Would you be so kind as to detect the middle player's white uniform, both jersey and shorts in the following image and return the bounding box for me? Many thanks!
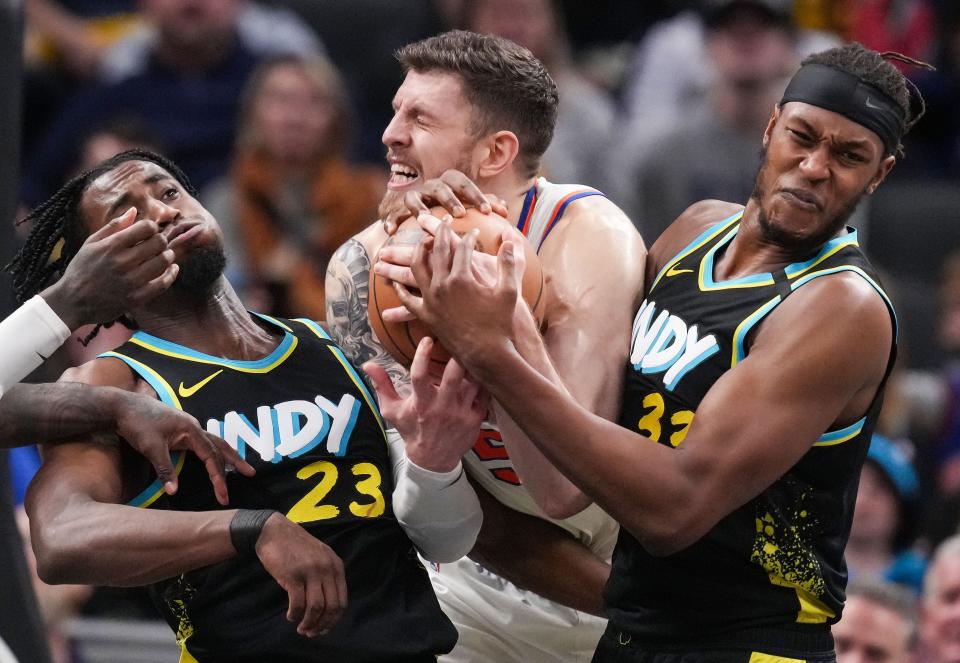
[436,177,619,663]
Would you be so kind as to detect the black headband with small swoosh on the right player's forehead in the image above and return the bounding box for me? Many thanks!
[780,64,904,154]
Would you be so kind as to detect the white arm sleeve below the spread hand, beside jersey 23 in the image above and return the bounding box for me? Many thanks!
[387,428,483,563]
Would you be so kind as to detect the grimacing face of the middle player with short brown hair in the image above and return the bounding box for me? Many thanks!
[383,70,488,211]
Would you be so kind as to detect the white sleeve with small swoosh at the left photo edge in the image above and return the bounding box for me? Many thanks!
[0,295,70,396]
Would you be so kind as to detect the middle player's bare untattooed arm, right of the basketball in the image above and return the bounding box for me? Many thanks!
[496,197,646,518]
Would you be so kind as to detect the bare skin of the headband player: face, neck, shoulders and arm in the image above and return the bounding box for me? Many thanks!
[394,102,895,555]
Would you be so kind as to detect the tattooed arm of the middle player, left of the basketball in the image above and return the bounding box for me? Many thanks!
[326,239,410,393]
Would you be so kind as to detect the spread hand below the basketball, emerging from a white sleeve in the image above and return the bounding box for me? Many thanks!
[363,337,490,472]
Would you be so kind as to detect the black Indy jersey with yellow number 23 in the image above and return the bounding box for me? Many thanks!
[103,316,456,663]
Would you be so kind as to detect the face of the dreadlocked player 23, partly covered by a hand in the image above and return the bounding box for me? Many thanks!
[79,160,225,289]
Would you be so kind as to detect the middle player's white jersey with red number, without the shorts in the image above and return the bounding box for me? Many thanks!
[463,177,618,561]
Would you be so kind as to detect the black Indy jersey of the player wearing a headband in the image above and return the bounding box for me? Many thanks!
[606,212,896,650]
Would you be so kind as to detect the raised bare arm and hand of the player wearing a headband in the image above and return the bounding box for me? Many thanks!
[403,226,892,554]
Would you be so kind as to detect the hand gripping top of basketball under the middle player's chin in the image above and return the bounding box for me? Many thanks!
[379,169,507,235]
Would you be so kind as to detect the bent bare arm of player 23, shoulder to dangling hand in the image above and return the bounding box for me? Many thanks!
[25,359,347,637]
